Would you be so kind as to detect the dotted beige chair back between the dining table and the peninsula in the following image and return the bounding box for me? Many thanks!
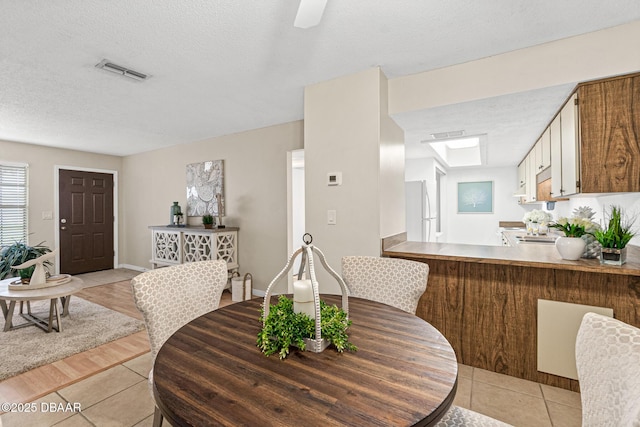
[342,256,429,314]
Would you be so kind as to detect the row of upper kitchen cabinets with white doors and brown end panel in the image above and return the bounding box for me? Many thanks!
[518,73,640,203]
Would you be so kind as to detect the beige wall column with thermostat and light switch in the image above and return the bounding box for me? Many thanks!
[304,68,404,292]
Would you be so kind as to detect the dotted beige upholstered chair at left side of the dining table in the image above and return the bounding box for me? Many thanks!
[131,260,228,426]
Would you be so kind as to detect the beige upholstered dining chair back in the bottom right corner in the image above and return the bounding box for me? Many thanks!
[576,313,640,427]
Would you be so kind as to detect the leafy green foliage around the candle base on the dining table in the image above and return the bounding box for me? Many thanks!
[257,295,357,359]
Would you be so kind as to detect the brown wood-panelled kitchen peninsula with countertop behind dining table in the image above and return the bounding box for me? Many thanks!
[382,235,640,391]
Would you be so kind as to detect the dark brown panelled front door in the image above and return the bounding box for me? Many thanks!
[58,169,114,274]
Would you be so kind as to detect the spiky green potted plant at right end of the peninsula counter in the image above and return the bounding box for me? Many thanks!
[593,206,636,265]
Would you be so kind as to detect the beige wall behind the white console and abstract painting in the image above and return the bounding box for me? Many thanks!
[121,121,303,290]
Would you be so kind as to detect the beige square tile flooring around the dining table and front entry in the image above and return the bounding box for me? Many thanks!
[1,270,581,427]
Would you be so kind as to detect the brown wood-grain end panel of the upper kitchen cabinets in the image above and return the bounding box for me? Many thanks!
[578,74,640,193]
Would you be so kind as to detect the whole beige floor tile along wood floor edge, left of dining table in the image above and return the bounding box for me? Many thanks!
[58,365,147,411]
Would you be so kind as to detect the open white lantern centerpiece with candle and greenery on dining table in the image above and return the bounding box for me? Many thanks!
[257,233,357,359]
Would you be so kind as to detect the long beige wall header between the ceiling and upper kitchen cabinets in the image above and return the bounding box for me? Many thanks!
[389,21,640,115]
